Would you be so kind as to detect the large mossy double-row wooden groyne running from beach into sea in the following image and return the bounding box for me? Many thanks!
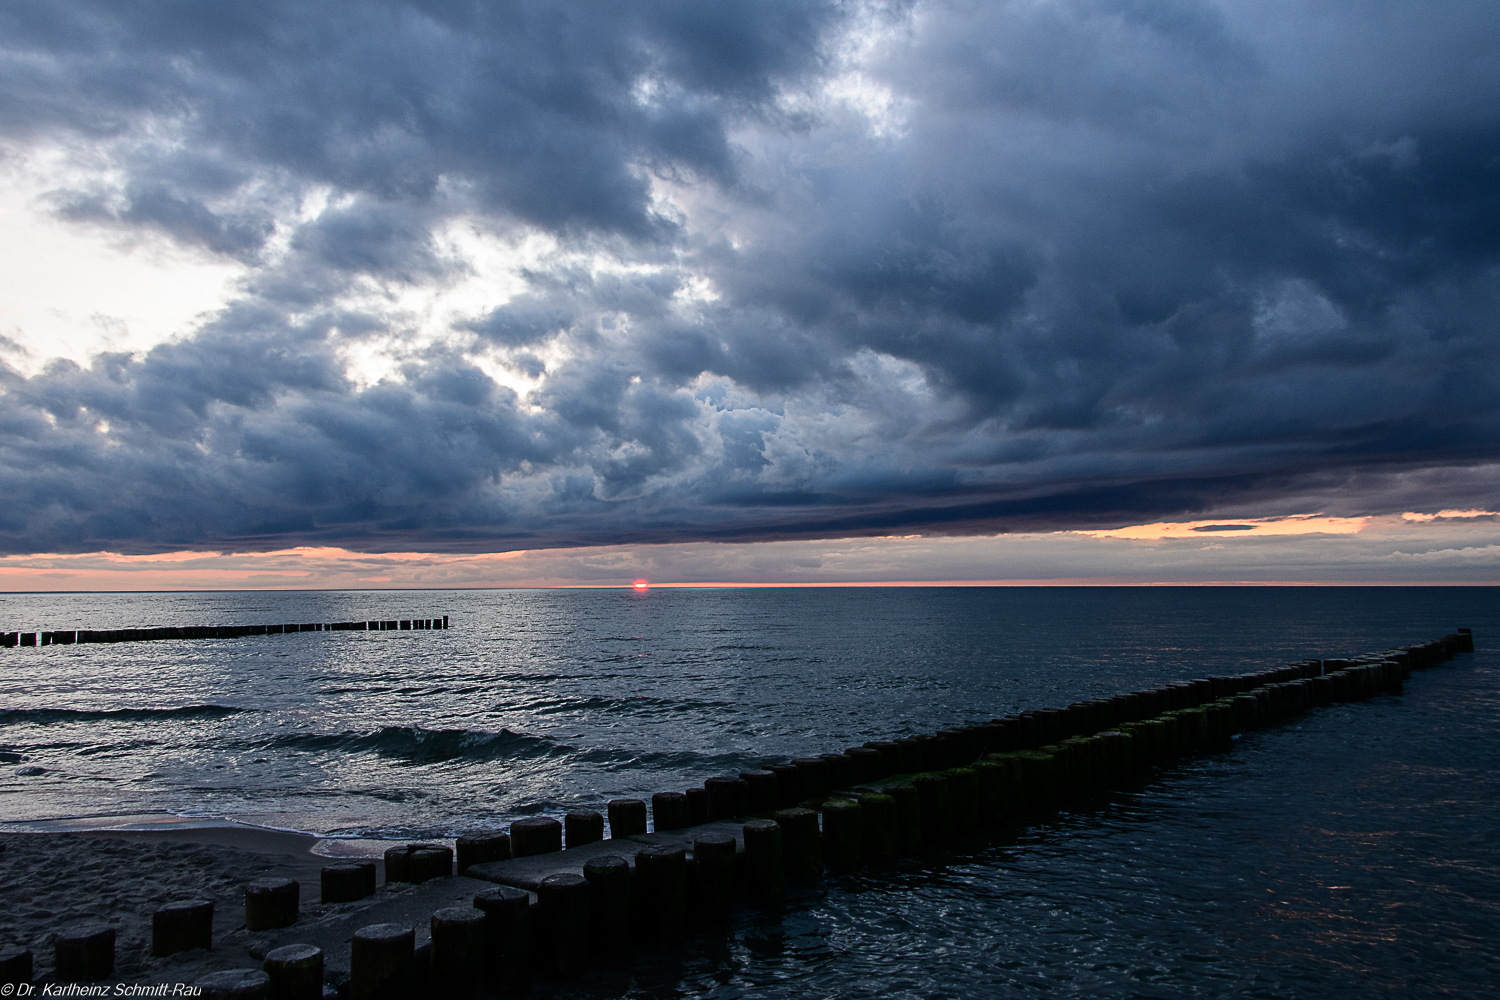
[0,628,1475,1000]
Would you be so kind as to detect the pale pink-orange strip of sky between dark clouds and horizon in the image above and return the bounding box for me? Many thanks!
[0,510,1500,592]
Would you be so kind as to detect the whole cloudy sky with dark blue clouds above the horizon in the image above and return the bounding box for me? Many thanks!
[0,0,1500,589]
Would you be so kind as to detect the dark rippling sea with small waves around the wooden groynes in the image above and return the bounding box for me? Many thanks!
[0,588,1500,1000]
